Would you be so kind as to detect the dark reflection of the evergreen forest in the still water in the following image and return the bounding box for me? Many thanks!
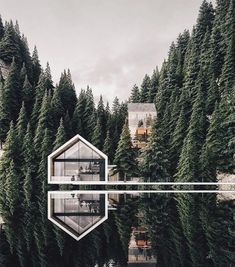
[0,194,235,267]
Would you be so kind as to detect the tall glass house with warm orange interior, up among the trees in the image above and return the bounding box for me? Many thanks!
[128,103,157,148]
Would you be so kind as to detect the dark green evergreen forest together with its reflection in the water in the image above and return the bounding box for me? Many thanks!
[0,0,235,267]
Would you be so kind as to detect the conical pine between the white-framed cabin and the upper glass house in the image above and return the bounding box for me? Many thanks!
[114,121,137,179]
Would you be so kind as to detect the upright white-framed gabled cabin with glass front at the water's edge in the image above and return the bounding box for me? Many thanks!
[48,135,108,184]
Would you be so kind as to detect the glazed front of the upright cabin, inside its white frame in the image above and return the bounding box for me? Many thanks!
[51,140,105,181]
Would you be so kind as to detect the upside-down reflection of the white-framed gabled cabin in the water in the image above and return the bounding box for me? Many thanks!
[48,191,108,240]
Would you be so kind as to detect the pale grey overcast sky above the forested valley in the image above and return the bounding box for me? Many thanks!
[0,0,216,101]
